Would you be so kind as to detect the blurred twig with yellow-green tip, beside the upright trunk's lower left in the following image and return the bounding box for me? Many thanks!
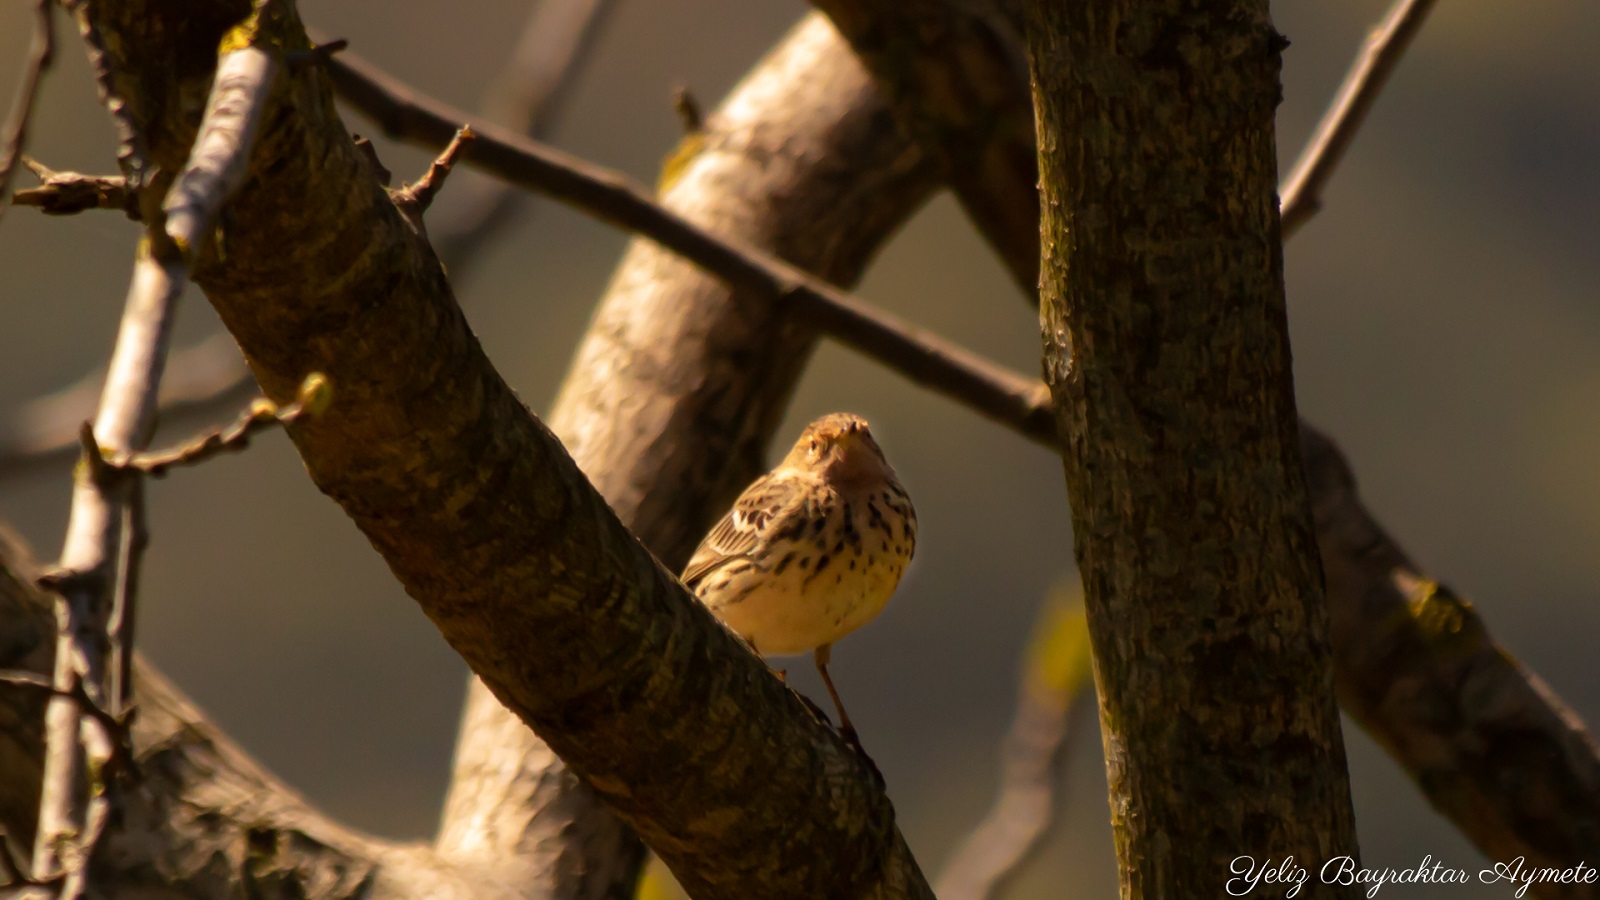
[936,591,1094,900]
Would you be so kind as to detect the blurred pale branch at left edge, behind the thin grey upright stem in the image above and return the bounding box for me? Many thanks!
[0,331,256,477]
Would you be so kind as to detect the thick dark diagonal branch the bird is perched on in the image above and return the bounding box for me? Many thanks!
[68,2,926,898]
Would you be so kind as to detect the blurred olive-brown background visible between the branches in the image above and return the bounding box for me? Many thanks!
[0,0,1600,898]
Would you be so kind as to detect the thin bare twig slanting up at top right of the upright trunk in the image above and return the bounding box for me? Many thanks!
[1280,0,1434,240]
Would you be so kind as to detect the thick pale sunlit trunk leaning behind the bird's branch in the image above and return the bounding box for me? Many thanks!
[438,16,934,897]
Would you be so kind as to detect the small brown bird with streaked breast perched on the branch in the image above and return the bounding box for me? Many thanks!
[683,413,917,749]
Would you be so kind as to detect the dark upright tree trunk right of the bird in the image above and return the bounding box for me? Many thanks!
[1029,0,1357,897]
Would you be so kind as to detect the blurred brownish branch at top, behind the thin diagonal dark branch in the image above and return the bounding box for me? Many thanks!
[434,0,618,262]
